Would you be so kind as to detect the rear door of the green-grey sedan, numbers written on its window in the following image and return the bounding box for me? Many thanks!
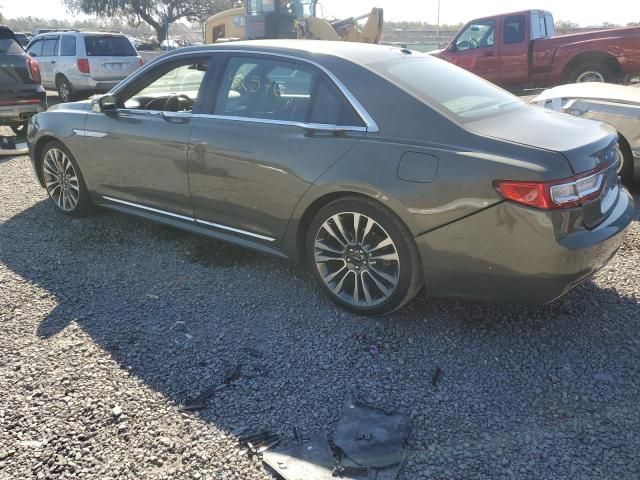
[189,55,366,244]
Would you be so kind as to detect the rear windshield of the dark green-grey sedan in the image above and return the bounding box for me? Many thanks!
[369,56,525,121]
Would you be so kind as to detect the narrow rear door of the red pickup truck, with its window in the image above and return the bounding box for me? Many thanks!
[500,15,531,85]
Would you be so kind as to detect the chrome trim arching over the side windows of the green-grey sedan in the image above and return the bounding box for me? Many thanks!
[115,48,380,133]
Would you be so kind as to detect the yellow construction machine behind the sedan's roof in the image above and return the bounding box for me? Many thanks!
[205,0,384,43]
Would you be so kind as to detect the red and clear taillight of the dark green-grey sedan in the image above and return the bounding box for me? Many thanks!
[493,165,611,210]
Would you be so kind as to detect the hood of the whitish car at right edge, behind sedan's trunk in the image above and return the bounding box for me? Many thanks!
[533,82,640,105]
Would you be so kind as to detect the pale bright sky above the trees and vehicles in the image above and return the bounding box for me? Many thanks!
[5,0,640,26]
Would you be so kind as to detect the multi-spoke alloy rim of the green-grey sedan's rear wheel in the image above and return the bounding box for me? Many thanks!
[314,212,400,308]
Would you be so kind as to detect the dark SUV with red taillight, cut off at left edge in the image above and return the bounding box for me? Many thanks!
[0,26,47,134]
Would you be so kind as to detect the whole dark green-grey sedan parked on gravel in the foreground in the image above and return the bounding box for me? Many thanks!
[28,41,634,314]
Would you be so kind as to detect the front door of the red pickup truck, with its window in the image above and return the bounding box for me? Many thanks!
[442,19,500,82]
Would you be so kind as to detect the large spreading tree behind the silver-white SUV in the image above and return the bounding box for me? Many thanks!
[64,0,231,42]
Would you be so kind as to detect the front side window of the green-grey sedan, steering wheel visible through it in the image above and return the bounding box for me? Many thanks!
[120,58,208,112]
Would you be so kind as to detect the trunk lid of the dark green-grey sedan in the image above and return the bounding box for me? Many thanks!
[465,106,617,174]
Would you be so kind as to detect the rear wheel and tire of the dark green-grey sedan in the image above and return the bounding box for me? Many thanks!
[305,197,424,316]
